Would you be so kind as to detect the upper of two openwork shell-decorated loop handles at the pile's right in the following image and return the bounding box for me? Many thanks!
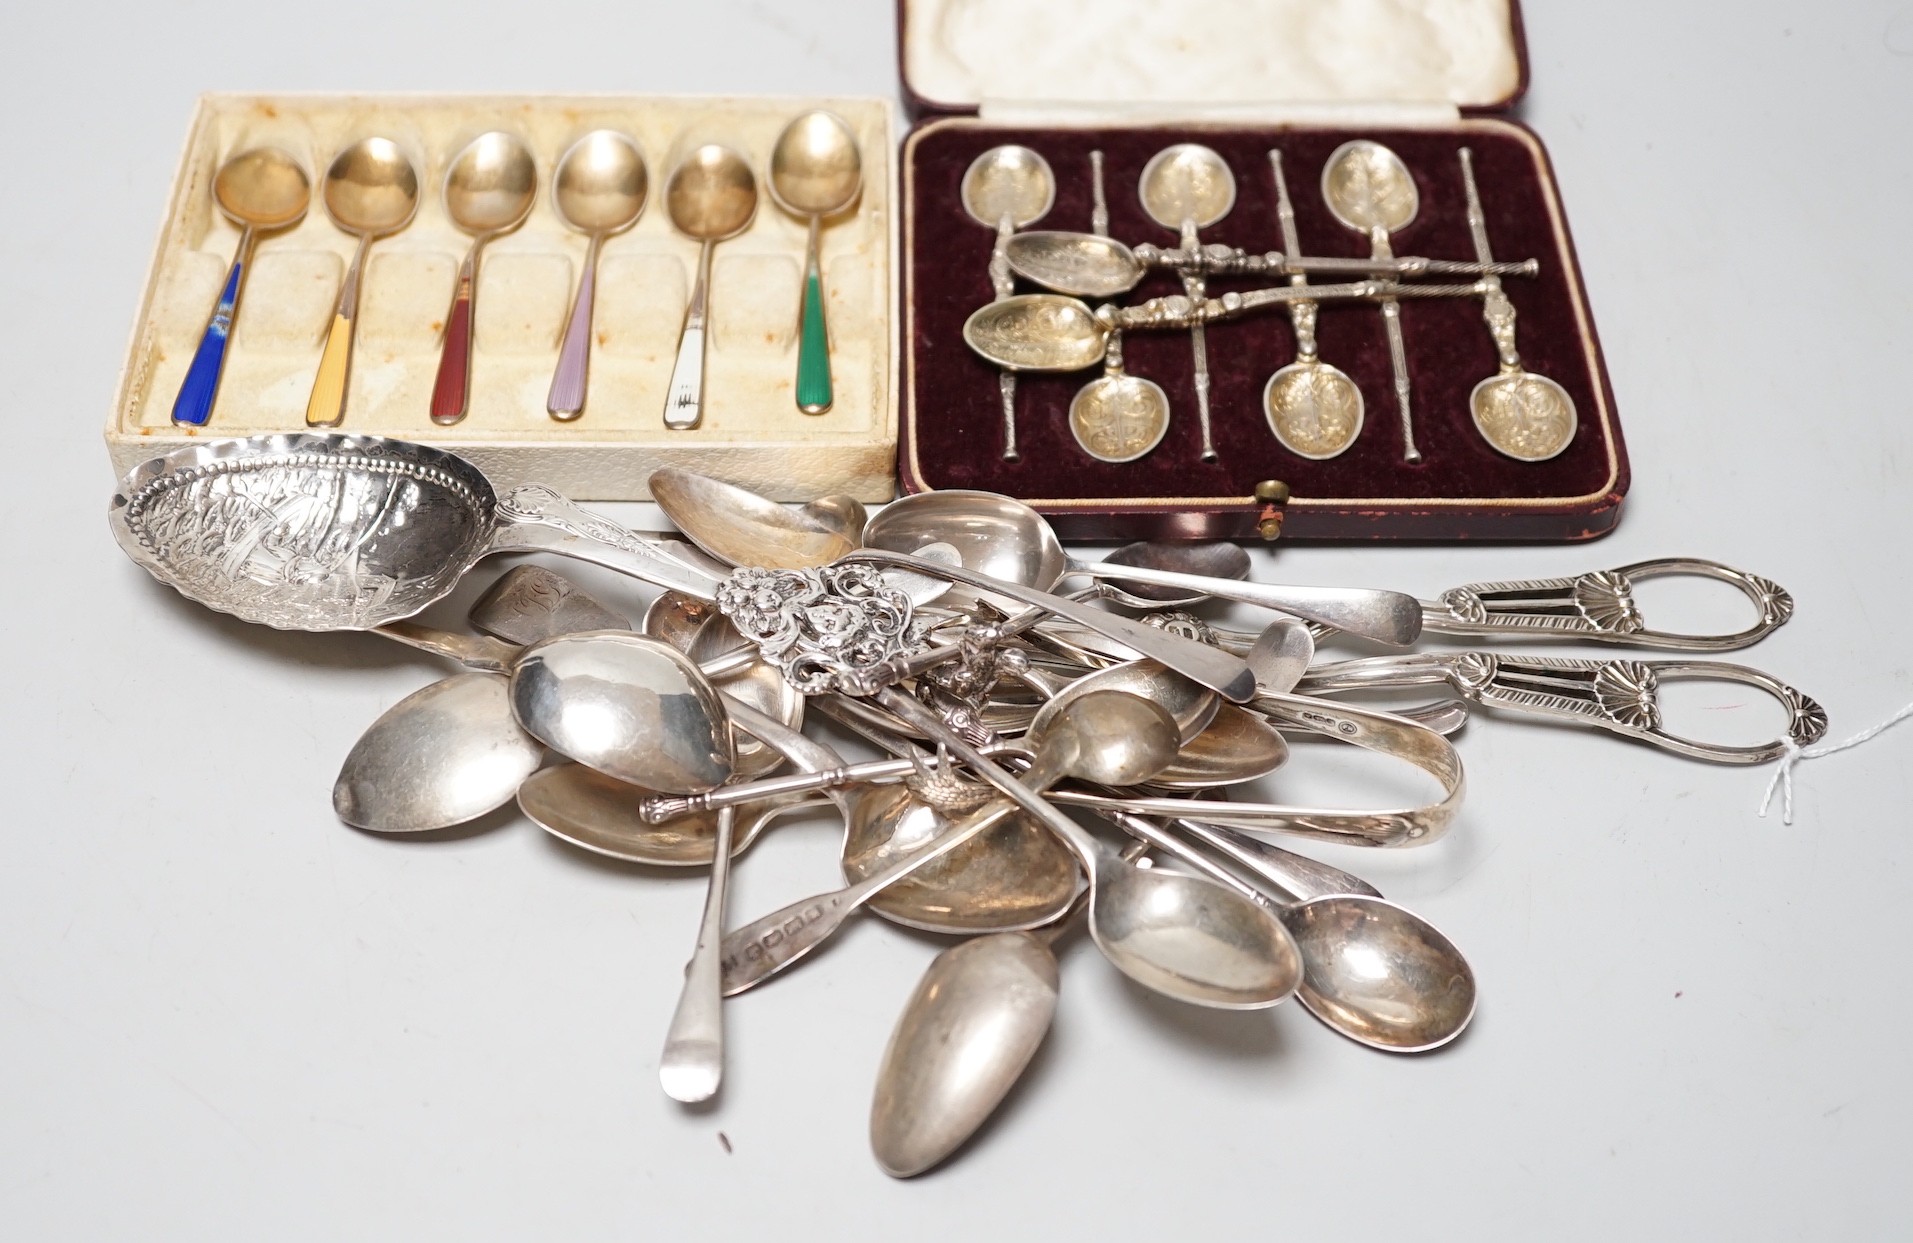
[1423,556,1792,652]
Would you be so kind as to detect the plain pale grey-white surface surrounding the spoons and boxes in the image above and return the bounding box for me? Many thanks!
[0,0,1913,1241]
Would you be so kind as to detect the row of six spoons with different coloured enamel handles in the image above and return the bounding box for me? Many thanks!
[172,109,863,430]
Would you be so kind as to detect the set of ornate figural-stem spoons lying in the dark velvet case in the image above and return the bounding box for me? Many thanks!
[962,140,1576,463]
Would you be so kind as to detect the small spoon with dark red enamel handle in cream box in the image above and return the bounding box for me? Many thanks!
[432,130,538,426]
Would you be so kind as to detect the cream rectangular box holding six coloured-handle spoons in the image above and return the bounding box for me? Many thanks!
[107,96,897,501]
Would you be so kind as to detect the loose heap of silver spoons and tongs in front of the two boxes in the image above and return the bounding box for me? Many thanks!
[111,436,1825,1176]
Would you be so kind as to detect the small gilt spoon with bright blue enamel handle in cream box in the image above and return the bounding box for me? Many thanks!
[172,147,312,426]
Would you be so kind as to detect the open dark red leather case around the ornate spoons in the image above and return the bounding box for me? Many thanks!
[899,0,1628,541]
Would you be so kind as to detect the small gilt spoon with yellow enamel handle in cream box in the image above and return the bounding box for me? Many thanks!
[306,138,419,426]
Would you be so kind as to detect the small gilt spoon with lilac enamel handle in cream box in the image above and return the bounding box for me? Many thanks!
[545,130,650,423]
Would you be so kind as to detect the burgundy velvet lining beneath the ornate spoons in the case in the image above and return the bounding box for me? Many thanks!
[905,124,1626,516]
